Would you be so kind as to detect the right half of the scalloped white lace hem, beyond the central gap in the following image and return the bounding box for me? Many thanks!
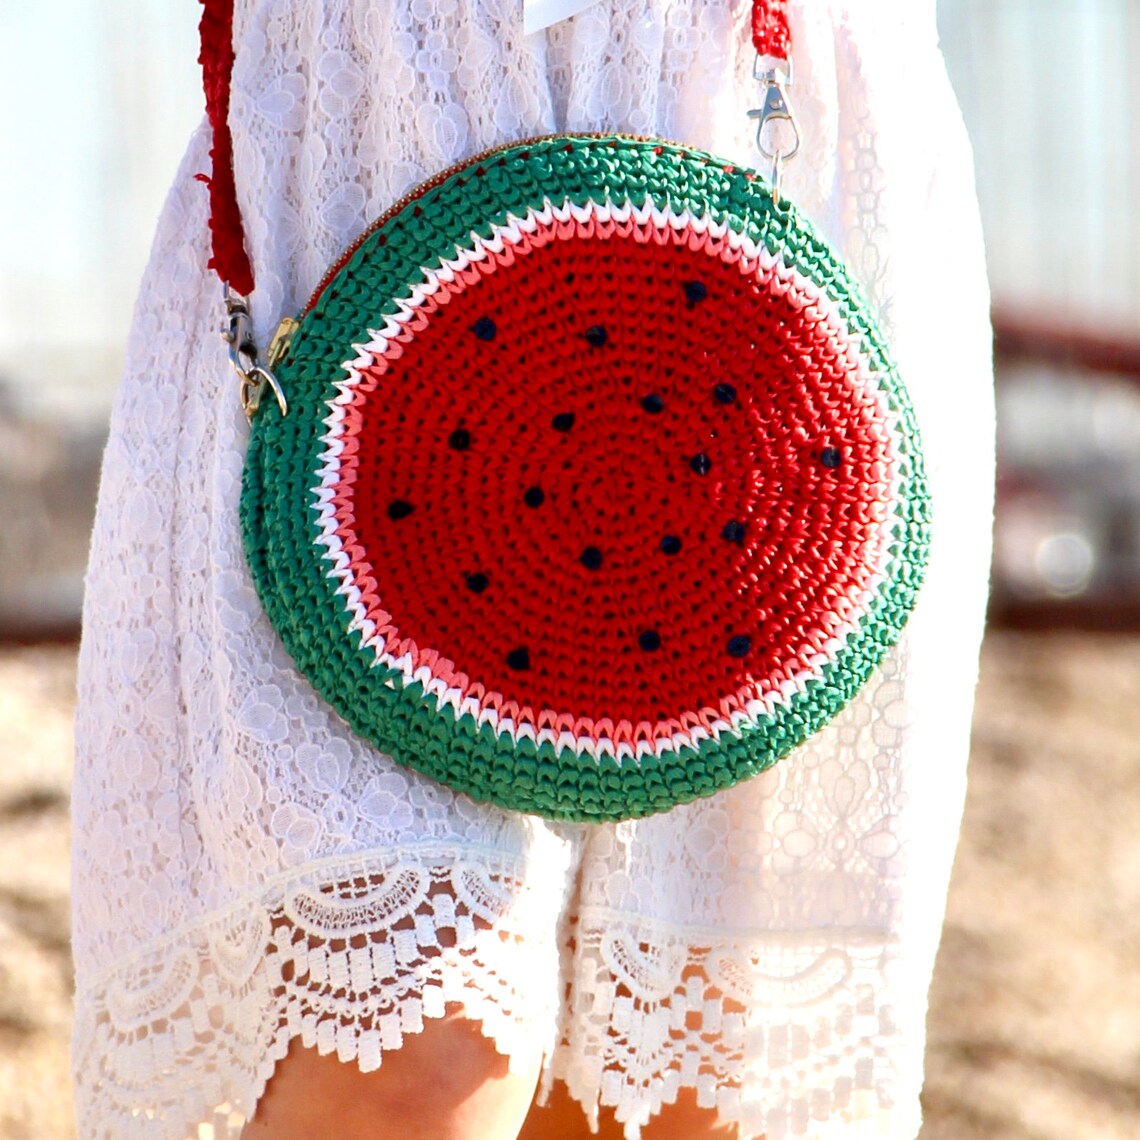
[543,911,922,1140]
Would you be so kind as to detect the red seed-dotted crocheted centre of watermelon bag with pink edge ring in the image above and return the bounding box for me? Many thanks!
[335,212,894,735]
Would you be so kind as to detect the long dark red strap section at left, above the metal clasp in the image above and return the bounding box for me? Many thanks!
[198,0,253,295]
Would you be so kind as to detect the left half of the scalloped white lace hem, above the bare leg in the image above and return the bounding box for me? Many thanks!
[72,847,563,1140]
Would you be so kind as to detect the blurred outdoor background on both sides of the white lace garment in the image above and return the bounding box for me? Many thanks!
[0,0,1140,1140]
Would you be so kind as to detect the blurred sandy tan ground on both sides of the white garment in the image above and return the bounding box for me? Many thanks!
[0,634,1140,1140]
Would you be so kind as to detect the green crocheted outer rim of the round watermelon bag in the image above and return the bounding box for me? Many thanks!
[241,136,930,822]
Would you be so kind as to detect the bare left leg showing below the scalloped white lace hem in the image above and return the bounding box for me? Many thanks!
[242,1005,542,1140]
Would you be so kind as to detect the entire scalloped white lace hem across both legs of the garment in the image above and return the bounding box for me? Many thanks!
[74,847,921,1140]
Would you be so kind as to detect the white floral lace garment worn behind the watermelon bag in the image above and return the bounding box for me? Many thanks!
[74,0,992,1140]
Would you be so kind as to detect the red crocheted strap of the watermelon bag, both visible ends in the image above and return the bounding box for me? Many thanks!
[198,0,791,295]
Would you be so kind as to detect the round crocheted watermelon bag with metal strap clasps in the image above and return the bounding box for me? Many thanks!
[205,0,929,821]
